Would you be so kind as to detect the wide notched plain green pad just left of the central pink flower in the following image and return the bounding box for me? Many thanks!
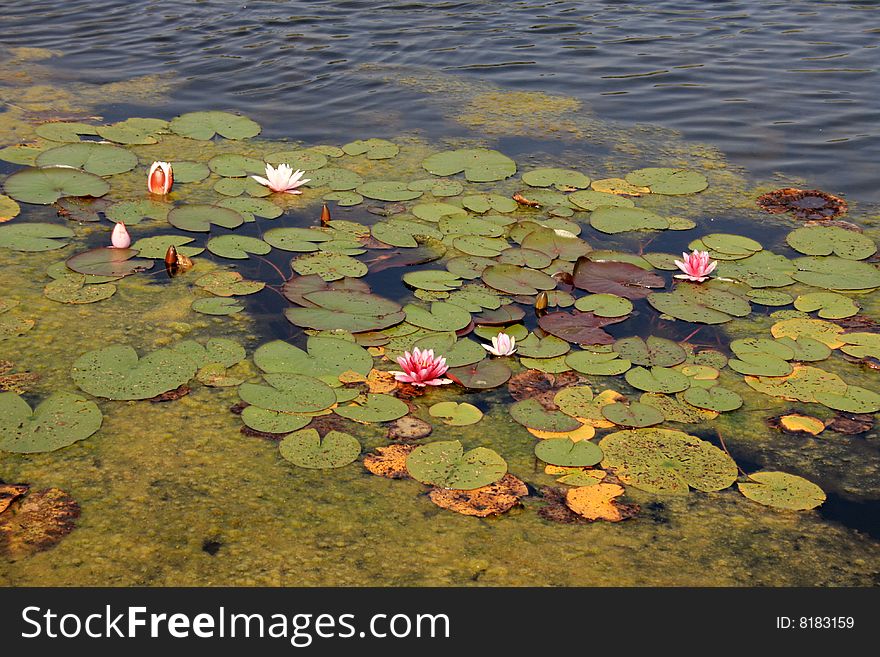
[254,335,373,377]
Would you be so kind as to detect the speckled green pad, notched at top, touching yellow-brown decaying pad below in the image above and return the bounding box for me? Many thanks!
[406,440,507,490]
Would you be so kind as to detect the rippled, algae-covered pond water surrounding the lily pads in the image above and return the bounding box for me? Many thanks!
[0,0,880,586]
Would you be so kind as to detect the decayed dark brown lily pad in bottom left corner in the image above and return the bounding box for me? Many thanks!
[0,488,80,559]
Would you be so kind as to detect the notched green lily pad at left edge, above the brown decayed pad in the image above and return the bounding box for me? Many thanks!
[0,392,103,454]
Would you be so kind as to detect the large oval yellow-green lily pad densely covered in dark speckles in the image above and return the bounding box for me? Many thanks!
[599,427,737,495]
